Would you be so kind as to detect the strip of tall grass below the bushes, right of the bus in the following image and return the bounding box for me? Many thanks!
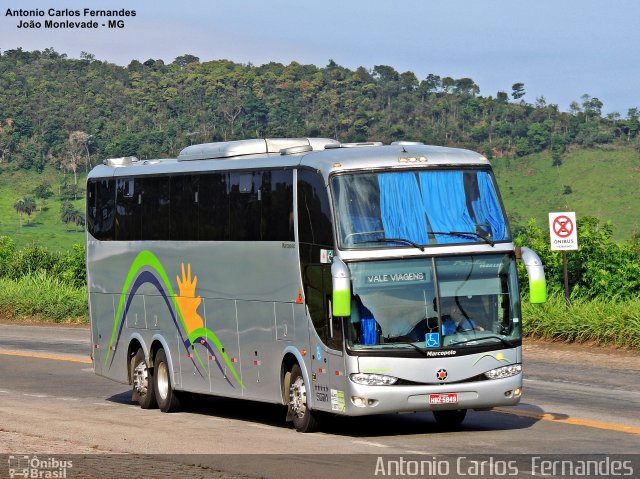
[522,293,640,350]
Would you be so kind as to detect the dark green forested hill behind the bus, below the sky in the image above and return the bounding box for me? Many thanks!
[0,49,640,170]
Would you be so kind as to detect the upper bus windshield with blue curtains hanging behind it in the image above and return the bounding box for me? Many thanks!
[331,169,510,249]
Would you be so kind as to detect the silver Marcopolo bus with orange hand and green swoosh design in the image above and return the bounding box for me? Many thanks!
[87,138,546,432]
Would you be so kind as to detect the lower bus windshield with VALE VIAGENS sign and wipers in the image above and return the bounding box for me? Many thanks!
[347,254,522,350]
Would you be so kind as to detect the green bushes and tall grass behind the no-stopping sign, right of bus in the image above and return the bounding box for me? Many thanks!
[515,217,640,350]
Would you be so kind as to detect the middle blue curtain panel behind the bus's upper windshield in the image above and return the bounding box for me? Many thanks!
[418,171,476,244]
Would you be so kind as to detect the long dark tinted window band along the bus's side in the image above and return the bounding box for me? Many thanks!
[92,170,296,241]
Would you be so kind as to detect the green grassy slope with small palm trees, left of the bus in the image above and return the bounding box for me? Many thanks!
[0,165,86,251]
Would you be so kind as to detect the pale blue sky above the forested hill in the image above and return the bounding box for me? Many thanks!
[0,0,640,117]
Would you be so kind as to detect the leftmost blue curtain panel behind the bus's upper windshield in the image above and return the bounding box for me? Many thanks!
[378,172,429,244]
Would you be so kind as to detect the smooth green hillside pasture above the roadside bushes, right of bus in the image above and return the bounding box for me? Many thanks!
[491,146,640,241]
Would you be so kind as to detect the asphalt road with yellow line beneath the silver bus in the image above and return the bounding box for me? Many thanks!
[0,325,640,479]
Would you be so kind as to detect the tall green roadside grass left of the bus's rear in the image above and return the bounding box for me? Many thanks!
[0,272,88,323]
